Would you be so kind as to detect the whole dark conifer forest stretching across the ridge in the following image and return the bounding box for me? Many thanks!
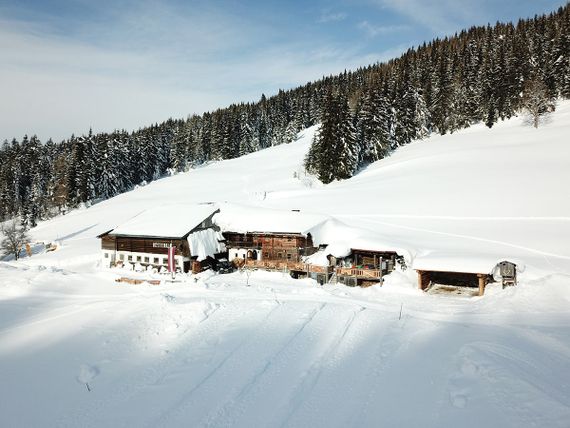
[0,5,570,227]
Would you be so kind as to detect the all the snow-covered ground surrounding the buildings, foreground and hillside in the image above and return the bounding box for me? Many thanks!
[0,102,570,427]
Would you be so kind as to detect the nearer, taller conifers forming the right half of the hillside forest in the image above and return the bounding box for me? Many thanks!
[305,5,570,183]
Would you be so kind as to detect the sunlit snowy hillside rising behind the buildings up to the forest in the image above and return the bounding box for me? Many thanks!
[28,102,570,273]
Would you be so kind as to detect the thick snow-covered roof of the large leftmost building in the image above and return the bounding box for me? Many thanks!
[110,204,218,238]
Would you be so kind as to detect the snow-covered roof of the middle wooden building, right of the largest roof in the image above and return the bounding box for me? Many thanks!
[214,204,329,235]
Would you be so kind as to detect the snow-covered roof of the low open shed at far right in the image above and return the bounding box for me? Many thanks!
[413,252,522,274]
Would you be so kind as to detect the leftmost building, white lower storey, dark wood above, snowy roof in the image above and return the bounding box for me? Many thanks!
[98,204,225,272]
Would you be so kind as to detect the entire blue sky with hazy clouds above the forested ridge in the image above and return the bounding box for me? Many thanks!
[0,0,566,141]
